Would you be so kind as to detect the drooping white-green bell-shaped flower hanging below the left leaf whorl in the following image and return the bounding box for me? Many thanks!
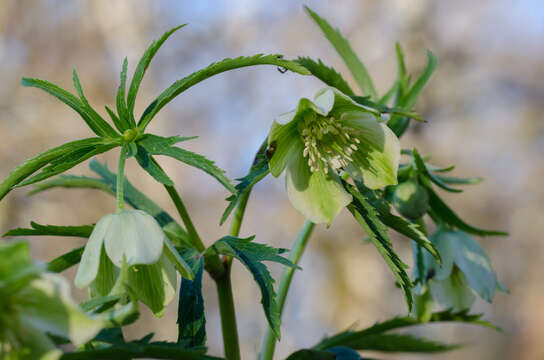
[75,210,193,316]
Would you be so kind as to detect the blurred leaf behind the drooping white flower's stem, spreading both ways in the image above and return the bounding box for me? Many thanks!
[30,160,192,247]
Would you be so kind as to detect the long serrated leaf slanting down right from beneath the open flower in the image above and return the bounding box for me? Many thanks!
[346,184,413,310]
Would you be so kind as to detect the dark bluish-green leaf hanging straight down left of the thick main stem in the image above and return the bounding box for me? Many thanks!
[177,250,206,346]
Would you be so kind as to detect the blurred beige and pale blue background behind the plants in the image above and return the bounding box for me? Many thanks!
[0,0,544,360]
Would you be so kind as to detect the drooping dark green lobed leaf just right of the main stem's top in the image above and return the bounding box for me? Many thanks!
[207,236,296,339]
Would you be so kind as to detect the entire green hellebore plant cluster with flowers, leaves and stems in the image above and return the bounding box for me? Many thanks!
[0,8,507,360]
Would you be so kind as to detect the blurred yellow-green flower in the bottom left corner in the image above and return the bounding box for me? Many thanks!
[0,242,104,360]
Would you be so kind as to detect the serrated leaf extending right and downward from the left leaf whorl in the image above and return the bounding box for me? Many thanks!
[138,135,236,194]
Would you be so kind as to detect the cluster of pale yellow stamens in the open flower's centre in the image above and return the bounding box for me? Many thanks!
[301,114,360,174]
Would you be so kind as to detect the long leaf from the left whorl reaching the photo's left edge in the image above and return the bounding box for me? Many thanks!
[0,138,110,200]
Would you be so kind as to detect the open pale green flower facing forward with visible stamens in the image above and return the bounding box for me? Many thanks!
[267,87,400,224]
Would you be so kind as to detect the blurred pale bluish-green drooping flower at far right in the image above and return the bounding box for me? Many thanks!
[424,229,505,310]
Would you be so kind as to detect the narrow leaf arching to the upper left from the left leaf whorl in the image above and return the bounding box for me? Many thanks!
[21,73,118,137]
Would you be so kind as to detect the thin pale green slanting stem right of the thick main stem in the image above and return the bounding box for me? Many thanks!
[259,220,315,360]
